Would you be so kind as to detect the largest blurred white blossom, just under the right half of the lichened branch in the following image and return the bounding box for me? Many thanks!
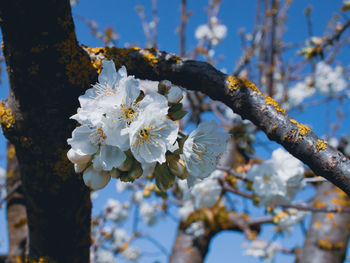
[247,148,305,205]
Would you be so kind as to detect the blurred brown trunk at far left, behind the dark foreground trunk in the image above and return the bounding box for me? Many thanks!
[6,144,29,263]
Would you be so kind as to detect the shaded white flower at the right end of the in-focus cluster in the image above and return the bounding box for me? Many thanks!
[183,121,229,182]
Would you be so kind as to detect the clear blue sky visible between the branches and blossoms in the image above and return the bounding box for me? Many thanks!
[0,0,349,263]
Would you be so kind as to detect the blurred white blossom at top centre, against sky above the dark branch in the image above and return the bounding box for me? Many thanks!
[195,17,227,46]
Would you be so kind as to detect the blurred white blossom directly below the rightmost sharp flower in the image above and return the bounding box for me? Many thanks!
[191,171,222,209]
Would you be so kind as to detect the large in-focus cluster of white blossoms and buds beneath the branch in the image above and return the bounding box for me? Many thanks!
[67,61,228,190]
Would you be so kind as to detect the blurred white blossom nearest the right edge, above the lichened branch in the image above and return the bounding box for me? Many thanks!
[315,61,347,96]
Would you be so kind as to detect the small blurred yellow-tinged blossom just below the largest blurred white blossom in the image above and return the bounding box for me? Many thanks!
[277,208,308,232]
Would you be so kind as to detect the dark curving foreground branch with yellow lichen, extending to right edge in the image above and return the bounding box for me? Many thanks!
[85,47,350,195]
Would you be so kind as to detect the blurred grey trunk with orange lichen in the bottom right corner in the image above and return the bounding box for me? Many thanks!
[296,182,350,263]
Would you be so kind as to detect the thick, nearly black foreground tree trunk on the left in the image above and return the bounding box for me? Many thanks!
[0,0,96,263]
